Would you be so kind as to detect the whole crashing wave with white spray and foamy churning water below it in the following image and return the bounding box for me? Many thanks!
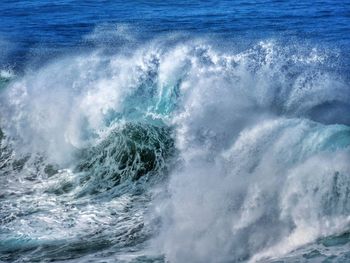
[0,36,350,262]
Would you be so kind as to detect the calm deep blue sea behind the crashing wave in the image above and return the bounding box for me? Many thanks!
[0,0,350,69]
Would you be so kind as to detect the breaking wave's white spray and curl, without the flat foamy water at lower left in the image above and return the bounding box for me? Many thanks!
[0,36,350,262]
